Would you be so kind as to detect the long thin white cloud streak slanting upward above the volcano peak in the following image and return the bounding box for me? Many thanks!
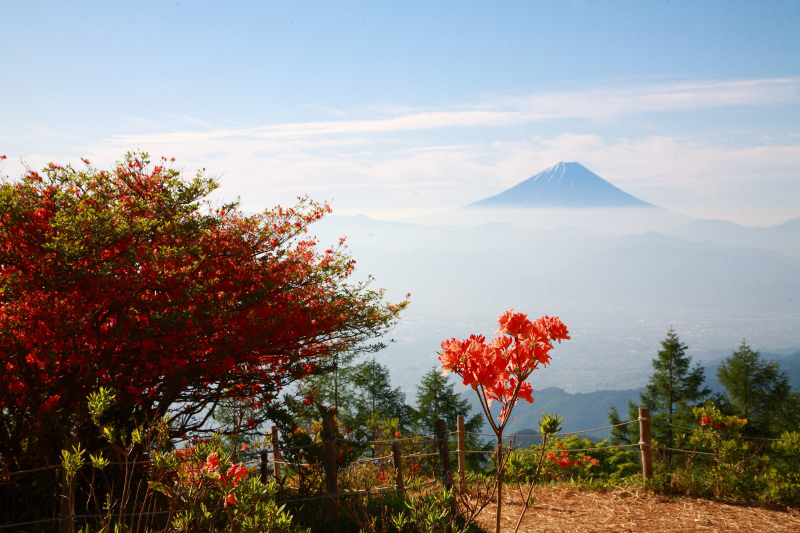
[108,78,800,146]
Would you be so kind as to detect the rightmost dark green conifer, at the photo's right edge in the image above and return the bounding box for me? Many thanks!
[717,340,800,436]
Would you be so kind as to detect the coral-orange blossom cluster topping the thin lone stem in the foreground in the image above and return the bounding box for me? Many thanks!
[439,309,570,419]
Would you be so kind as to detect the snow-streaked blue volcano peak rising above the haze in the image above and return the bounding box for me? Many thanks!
[467,162,656,209]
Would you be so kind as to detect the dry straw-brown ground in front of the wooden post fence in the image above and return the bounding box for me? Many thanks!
[468,486,800,533]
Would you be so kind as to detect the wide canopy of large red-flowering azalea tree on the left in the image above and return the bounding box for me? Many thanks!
[0,153,407,470]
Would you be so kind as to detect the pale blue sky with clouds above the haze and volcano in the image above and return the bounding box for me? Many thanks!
[0,0,800,225]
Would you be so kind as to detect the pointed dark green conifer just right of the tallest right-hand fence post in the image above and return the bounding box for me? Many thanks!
[639,327,711,460]
